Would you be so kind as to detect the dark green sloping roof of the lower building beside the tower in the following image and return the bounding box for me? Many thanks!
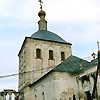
[53,56,90,73]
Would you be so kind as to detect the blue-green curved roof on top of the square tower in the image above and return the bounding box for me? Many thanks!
[31,30,71,45]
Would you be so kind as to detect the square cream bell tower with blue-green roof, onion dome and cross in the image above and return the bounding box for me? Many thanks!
[18,0,72,100]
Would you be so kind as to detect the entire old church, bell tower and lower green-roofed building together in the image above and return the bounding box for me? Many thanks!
[18,1,100,100]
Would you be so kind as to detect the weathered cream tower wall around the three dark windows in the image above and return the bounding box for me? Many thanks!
[19,38,72,90]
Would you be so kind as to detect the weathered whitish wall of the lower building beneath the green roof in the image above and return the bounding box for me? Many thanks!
[27,72,78,100]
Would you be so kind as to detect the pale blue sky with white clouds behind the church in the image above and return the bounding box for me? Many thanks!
[0,0,100,91]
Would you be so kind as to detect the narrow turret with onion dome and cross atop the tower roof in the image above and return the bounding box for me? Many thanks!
[38,0,47,30]
